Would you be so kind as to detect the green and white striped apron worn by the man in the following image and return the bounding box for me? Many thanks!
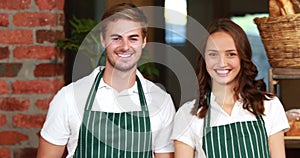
[74,70,152,158]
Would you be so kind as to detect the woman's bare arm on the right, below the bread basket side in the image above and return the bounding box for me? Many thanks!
[269,131,285,158]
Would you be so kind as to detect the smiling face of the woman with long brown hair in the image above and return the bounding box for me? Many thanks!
[204,32,241,86]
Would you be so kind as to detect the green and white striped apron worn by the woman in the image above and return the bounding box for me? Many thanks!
[202,92,270,158]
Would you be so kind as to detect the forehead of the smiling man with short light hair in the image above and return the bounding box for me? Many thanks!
[106,19,142,36]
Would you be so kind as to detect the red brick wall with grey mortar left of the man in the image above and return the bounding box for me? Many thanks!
[0,0,64,158]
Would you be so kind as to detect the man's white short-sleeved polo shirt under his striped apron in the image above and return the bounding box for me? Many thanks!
[41,67,175,158]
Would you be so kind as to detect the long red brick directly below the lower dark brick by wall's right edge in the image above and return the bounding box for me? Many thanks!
[12,80,60,94]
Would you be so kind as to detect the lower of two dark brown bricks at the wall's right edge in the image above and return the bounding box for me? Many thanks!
[34,63,64,77]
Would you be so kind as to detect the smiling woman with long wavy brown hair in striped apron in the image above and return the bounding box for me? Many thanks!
[172,19,289,158]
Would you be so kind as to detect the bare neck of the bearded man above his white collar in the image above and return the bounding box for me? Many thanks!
[103,68,136,92]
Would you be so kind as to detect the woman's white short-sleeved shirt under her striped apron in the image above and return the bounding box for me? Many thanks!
[171,93,289,158]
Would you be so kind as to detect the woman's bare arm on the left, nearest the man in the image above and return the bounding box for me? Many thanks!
[174,140,194,158]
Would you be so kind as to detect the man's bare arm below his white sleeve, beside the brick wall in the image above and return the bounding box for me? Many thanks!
[37,137,65,158]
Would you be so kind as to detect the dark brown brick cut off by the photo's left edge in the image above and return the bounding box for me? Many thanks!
[0,63,22,77]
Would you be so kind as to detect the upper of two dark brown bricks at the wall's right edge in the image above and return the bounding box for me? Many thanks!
[36,30,64,43]
